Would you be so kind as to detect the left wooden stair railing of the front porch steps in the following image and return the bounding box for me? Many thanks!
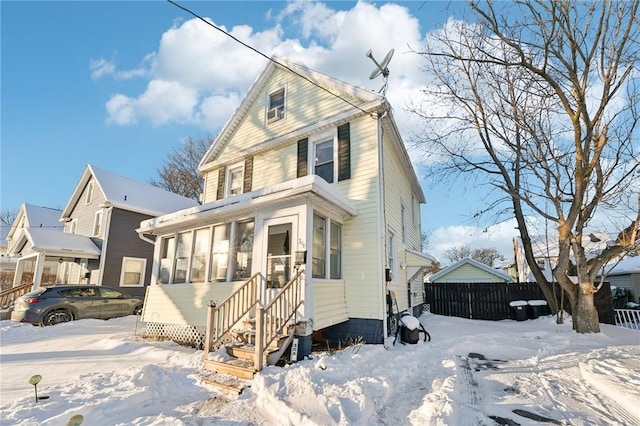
[205,273,262,359]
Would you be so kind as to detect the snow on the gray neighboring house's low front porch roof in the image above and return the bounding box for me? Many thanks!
[25,228,100,257]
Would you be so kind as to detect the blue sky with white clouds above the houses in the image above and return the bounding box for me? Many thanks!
[0,1,513,256]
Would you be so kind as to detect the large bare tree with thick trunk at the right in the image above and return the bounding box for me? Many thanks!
[413,0,640,333]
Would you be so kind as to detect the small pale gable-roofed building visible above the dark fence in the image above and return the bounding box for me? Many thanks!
[428,257,512,283]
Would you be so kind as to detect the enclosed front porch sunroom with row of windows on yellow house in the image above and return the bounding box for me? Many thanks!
[138,175,357,338]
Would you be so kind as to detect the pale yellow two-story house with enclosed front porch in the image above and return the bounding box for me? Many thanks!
[138,58,433,352]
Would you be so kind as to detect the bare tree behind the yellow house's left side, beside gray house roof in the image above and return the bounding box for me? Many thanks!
[149,137,212,201]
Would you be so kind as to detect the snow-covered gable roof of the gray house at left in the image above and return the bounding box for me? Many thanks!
[62,164,198,219]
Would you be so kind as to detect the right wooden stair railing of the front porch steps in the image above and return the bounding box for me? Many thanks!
[254,270,304,371]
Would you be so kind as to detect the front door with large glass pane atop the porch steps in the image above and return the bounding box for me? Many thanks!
[264,217,296,288]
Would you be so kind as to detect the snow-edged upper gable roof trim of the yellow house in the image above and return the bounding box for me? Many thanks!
[198,56,386,172]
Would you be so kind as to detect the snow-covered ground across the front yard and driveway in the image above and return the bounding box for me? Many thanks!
[0,314,640,426]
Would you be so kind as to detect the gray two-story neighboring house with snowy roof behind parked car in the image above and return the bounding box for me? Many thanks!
[10,165,198,295]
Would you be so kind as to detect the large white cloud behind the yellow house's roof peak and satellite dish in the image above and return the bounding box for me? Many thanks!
[100,2,430,137]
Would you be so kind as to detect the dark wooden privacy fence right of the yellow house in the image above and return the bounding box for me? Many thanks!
[424,283,546,320]
